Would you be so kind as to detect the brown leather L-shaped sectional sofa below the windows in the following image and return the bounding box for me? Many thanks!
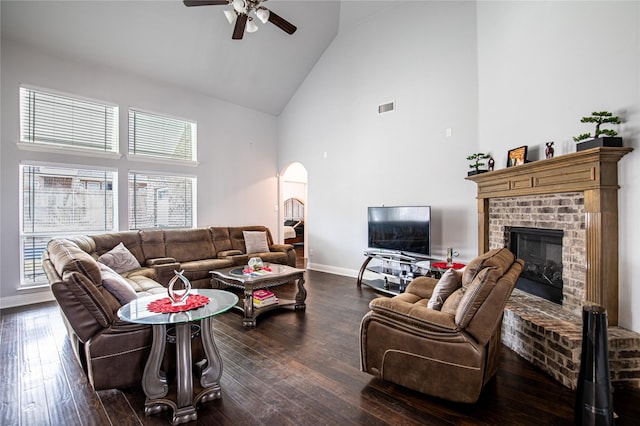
[42,226,296,390]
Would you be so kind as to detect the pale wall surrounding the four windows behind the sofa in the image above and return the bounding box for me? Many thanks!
[0,40,278,307]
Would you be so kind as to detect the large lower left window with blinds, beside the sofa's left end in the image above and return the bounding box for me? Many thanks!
[20,164,117,286]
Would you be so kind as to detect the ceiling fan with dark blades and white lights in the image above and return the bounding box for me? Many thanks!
[184,0,297,40]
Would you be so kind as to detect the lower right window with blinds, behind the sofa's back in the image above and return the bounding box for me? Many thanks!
[129,172,196,229]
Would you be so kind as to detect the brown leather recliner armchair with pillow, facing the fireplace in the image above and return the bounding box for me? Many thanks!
[360,248,524,403]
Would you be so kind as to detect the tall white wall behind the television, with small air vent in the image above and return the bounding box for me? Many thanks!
[278,2,477,276]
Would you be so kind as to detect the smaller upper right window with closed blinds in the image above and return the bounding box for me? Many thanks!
[129,109,197,162]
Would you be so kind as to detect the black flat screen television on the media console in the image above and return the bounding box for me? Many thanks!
[368,206,431,256]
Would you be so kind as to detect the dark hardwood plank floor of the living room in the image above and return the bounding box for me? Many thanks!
[0,271,640,426]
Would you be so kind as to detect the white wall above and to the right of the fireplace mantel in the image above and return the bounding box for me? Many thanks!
[478,1,640,331]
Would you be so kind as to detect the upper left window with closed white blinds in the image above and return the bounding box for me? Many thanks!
[20,87,118,153]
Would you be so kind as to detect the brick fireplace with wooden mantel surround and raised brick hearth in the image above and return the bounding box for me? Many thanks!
[467,148,640,389]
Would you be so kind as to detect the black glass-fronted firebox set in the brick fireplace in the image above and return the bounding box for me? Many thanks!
[509,227,564,305]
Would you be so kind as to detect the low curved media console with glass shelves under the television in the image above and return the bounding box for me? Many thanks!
[357,251,438,295]
